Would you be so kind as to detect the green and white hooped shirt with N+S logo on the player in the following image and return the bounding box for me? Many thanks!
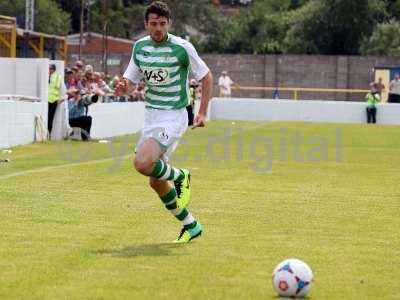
[124,33,209,109]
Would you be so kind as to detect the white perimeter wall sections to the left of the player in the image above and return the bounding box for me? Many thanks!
[0,58,144,148]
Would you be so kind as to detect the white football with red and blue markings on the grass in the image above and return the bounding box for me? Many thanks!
[272,258,313,298]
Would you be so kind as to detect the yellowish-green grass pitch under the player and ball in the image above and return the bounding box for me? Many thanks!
[0,121,400,300]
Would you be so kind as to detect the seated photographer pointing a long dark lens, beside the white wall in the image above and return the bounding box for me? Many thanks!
[68,88,98,141]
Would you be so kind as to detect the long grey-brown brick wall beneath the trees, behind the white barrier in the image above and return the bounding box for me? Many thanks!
[67,49,400,101]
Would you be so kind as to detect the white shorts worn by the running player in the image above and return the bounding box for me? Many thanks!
[136,107,188,161]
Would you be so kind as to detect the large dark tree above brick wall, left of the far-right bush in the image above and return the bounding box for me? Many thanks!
[285,0,386,55]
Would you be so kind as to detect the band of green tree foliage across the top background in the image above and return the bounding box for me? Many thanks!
[0,0,400,55]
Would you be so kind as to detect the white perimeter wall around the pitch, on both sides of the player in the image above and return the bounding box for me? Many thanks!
[0,58,400,148]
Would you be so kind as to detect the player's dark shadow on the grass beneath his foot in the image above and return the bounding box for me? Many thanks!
[93,243,184,258]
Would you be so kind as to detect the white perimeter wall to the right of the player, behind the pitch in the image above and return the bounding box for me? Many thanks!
[210,98,400,124]
